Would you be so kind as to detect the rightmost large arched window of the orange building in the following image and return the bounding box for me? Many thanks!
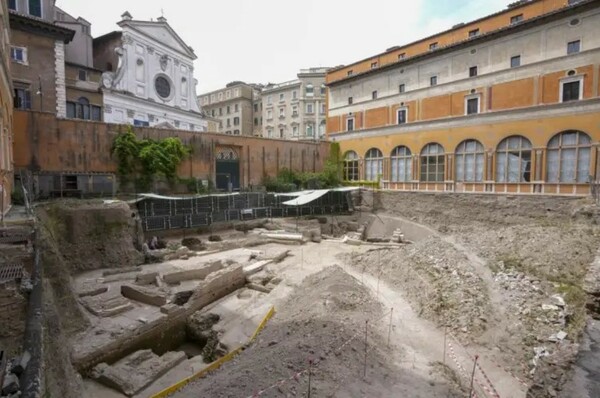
[546,130,592,183]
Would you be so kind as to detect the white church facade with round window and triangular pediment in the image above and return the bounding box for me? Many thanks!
[93,12,207,132]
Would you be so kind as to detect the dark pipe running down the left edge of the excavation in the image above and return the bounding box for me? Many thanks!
[21,228,43,398]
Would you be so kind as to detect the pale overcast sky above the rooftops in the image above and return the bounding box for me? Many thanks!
[56,0,513,94]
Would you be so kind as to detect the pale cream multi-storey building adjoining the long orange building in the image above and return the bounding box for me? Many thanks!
[261,68,329,140]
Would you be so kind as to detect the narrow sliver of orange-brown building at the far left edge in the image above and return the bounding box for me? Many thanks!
[0,1,13,220]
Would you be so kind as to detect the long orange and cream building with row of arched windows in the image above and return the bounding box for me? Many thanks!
[327,0,600,195]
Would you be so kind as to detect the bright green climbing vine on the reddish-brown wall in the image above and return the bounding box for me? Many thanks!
[112,127,192,188]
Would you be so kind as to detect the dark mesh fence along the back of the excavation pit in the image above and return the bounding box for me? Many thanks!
[136,191,351,231]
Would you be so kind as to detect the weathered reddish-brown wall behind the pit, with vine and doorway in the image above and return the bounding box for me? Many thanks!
[14,111,329,186]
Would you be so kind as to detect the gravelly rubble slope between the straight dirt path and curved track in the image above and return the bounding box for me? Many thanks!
[350,237,492,340]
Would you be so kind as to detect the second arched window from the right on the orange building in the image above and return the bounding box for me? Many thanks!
[496,135,531,183]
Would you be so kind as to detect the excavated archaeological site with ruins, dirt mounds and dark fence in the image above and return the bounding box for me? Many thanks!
[0,188,600,398]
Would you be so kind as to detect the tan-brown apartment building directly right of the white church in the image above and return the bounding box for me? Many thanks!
[198,81,262,136]
